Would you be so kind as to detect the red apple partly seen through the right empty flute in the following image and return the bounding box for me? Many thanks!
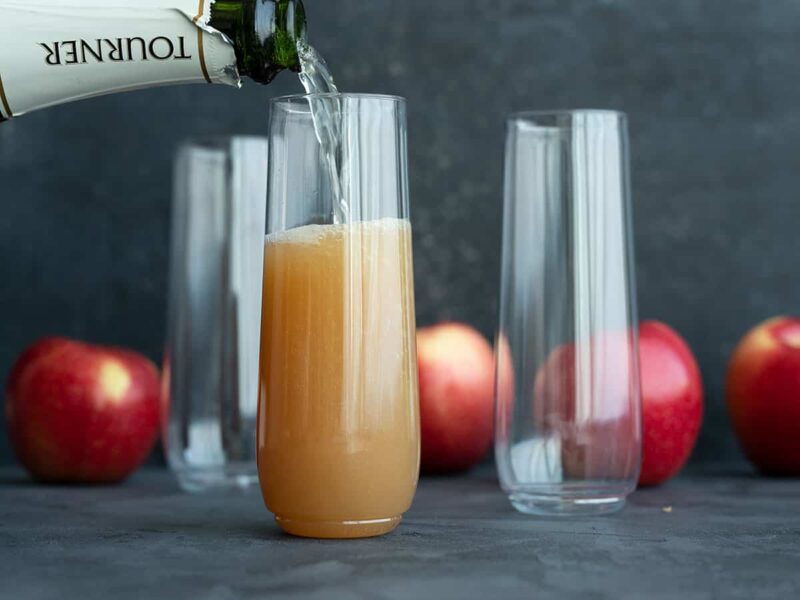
[534,321,703,486]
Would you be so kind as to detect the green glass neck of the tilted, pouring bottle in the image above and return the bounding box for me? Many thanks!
[209,0,306,83]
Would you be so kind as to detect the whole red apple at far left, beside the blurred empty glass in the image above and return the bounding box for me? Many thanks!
[6,337,159,483]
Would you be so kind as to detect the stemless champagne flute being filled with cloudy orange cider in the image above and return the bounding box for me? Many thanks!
[257,94,419,538]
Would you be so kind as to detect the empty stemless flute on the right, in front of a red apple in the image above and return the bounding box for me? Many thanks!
[495,110,641,515]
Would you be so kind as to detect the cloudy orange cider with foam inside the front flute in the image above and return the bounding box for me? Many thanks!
[258,219,419,538]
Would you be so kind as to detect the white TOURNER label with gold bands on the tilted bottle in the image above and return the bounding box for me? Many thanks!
[0,0,239,121]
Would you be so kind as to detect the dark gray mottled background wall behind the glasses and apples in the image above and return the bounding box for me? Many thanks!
[0,0,800,461]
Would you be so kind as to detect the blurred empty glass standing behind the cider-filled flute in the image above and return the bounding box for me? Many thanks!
[162,137,268,491]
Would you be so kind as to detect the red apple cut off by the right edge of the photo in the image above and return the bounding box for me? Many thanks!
[726,317,800,475]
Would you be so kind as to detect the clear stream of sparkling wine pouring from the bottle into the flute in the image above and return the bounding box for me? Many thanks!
[297,40,349,223]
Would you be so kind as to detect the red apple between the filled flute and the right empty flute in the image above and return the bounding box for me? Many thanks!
[417,323,494,473]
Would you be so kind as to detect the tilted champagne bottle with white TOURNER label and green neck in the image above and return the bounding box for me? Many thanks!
[0,0,305,121]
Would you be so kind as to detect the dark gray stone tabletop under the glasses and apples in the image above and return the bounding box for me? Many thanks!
[0,469,800,600]
